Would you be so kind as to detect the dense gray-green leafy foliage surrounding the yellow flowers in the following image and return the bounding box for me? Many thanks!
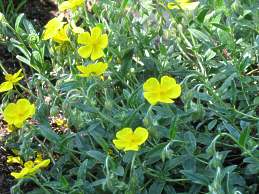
[0,0,259,194]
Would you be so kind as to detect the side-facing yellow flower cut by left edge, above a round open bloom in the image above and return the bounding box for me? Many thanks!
[0,69,23,92]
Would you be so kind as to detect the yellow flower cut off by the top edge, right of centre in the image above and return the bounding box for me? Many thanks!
[167,0,200,11]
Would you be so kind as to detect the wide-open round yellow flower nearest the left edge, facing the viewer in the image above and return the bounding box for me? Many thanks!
[3,99,35,128]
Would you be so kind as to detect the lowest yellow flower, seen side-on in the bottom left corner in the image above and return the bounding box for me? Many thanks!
[11,159,50,179]
